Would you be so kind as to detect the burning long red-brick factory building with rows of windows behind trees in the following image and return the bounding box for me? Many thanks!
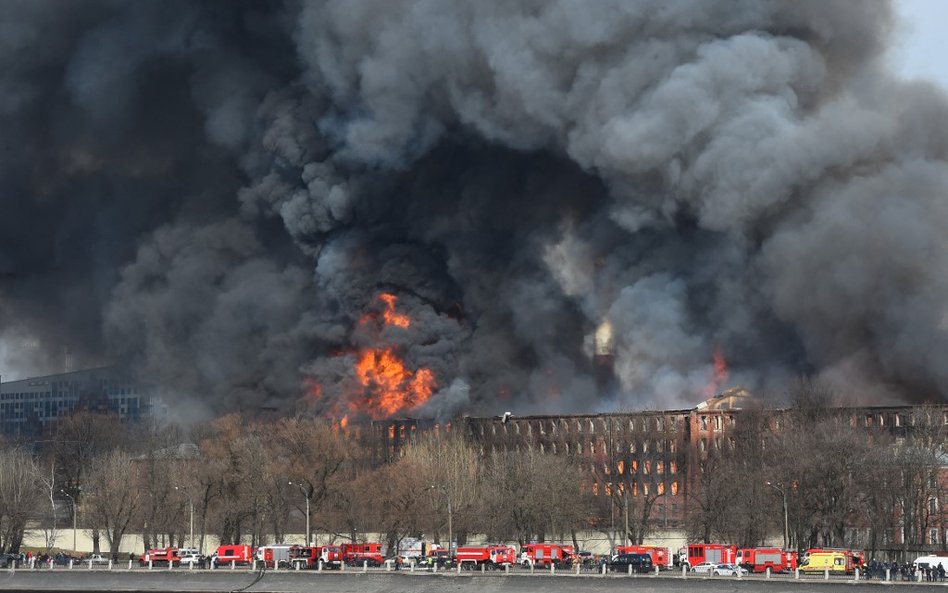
[373,388,948,546]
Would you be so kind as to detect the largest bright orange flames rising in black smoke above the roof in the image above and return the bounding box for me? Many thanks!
[309,293,437,418]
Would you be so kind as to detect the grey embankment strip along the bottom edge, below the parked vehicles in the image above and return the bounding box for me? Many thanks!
[0,569,945,593]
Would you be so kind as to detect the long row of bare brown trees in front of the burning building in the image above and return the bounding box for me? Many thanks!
[0,382,948,556]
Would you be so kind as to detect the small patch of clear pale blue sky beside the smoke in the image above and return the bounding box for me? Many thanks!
[890,0,948,89]
